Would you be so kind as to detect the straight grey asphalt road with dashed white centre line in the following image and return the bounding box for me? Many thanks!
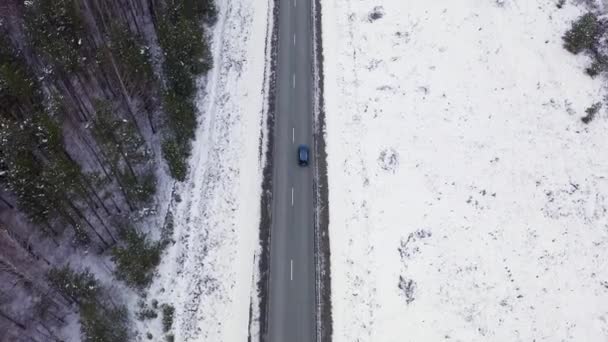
[268,0,316,342]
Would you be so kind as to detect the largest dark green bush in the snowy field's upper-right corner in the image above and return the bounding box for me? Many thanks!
[563,13,602,54]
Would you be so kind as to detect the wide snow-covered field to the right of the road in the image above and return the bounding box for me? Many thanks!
[323,0,608,342]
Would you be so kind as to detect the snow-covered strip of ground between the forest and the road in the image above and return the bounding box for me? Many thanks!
[139,0,269,342]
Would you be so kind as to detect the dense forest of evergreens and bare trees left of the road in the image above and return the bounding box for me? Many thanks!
[0,0,217,342]
